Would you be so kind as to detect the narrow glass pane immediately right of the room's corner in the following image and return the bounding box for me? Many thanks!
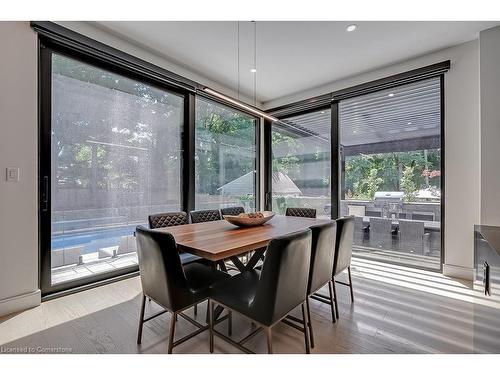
[270,107,332,218]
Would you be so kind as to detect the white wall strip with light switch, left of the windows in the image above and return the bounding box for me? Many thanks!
[0,22,40,316]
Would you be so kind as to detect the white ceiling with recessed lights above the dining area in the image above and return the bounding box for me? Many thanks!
[94,21,500,103]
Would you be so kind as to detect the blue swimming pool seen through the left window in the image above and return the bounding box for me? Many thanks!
[51,225,141,254]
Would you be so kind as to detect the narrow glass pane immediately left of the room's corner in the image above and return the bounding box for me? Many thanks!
[195,97,258,212]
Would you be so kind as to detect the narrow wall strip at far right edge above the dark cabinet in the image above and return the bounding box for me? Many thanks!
[479,27,500,225]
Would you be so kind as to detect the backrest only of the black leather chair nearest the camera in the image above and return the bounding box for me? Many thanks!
[251,229,311,326]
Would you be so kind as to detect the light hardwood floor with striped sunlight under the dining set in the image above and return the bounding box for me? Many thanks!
[0,259,500,353]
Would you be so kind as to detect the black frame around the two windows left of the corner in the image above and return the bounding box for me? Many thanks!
[35,22,261,300]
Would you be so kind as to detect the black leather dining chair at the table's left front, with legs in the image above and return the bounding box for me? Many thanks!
[136,226,230,353]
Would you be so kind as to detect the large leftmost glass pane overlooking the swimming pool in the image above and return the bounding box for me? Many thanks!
[41,48,184,293]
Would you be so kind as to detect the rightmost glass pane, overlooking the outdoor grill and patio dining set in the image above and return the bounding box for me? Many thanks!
[339,77,442,269]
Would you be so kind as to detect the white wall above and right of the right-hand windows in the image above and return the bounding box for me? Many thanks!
[263,40,482,278]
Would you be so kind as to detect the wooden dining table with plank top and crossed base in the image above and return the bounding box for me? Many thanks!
[155,216,330,271]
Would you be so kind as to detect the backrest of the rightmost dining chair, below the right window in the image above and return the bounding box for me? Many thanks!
[333,216,354,276]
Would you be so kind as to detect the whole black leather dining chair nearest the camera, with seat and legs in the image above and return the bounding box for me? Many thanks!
[210,229,311,353]
